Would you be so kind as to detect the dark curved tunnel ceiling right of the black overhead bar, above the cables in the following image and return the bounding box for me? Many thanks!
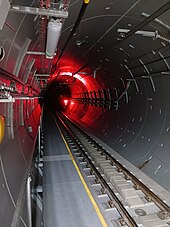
[53,0,169,85]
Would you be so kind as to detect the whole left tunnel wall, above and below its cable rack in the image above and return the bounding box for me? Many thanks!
[0,1,41,224]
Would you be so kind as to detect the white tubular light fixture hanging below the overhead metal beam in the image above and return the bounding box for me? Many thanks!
[46,19,62,59]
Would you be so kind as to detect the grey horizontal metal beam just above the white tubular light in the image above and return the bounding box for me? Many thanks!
[10,5,68,18]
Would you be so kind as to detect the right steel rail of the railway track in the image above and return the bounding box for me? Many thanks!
[61,113,170,217]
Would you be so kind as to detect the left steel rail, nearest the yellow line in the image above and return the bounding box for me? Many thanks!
[58,116,138,227]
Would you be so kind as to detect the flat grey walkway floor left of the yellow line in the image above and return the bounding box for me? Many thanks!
[43,109,102,227]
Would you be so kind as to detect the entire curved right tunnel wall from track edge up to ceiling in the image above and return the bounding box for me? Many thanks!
[53,1,170,190]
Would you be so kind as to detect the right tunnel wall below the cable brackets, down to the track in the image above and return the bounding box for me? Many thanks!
[63,71,170,190]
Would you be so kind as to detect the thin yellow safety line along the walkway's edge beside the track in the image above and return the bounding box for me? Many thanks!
[57,121,108,227]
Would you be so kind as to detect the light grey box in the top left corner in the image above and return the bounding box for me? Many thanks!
[0,0,10,30]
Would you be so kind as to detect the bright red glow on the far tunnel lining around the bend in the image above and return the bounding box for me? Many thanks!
[52,57,105,126]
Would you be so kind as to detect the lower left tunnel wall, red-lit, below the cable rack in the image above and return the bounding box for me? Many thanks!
[0,99,41,226]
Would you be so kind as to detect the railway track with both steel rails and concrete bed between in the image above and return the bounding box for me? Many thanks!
[57,114,170,227]
